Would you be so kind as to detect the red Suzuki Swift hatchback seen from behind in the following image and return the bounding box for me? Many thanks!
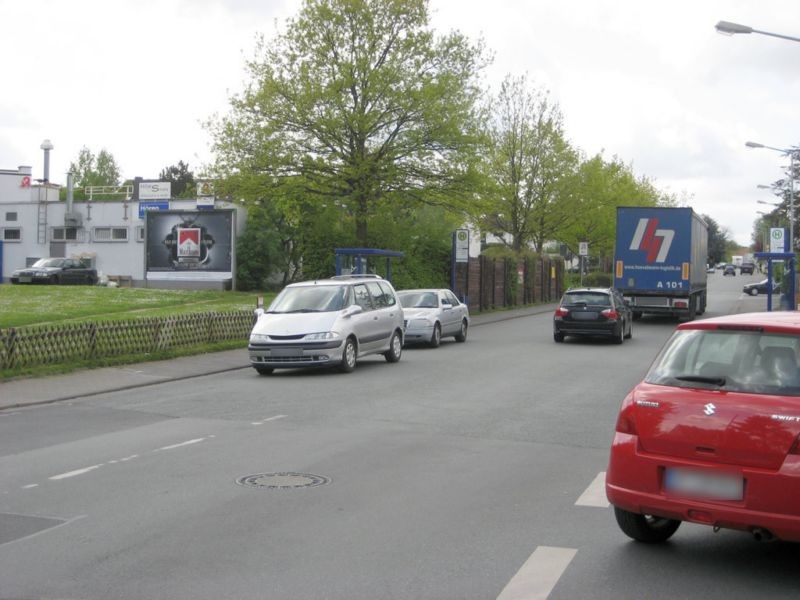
[606,311,800,543]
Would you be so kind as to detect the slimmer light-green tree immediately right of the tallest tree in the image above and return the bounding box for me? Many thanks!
[479,76,579,251]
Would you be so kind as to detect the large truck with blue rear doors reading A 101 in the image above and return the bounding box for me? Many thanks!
[614,206,708,321]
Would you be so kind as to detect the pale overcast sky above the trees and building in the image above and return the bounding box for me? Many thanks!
[0,0,800,245]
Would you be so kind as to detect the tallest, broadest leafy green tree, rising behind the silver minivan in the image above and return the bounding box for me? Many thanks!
[208,0,484,245]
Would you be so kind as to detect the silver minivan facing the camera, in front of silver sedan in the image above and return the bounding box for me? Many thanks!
[247,276,403,375]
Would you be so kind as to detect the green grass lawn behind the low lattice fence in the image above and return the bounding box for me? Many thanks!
[0,284,275,329]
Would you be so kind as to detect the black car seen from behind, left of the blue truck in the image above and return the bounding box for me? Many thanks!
[553,288,633,344]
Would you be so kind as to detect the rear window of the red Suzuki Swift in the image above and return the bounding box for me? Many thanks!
[645,329,800,396]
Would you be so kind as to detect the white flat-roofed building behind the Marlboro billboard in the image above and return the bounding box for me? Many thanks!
[0,158,246,288]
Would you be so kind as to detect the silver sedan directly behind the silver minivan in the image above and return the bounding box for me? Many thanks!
[397,289,469,348]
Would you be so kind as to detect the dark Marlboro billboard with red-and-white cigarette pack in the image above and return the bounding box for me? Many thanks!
[144,210,234,276]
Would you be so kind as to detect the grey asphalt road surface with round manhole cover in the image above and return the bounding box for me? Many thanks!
[0,273,800,600]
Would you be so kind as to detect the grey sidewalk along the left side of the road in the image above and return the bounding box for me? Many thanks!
[0,304,555,410]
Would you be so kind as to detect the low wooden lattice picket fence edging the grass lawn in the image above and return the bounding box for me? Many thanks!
[0,311,254,370]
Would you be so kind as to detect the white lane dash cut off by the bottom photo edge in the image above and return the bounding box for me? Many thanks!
[497,546,578,600]
